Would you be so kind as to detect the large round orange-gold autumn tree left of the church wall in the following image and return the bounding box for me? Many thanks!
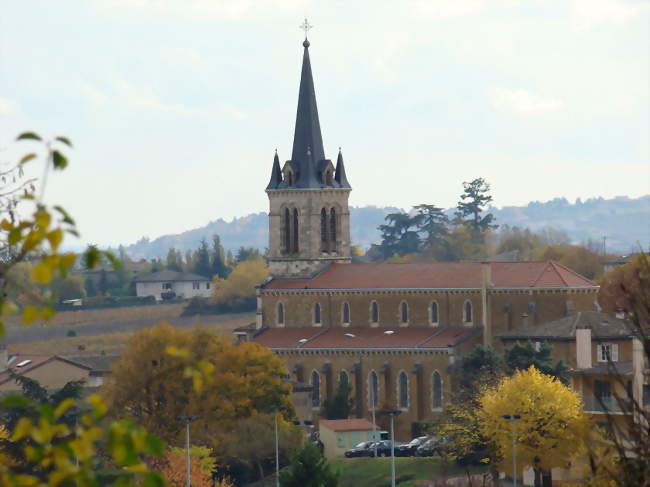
[103,323,293,448]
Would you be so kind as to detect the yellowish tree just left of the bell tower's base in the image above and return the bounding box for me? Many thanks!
[212,258,269,310]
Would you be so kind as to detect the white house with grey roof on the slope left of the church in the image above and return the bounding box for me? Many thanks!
[134,270,212,301]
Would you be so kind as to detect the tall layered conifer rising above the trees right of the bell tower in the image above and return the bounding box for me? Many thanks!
[456,178,498,241]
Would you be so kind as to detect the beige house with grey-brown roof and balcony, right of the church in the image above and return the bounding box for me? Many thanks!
[497,312,650,482]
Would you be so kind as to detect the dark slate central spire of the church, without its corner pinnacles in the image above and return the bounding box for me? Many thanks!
[291,39,325,188]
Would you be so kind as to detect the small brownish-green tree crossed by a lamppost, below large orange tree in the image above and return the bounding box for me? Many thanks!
[217,414,302,480]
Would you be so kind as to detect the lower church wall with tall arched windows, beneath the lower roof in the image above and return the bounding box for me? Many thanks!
[277,350,452,441]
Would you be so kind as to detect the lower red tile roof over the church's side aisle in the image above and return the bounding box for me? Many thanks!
[253,327,480,350]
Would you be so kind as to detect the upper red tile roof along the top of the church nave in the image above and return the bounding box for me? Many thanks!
[264,261,596,289]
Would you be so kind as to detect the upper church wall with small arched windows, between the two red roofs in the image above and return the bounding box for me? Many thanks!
[261,289,596,332]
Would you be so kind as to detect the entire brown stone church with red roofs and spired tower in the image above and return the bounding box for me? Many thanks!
[240,34,598,441]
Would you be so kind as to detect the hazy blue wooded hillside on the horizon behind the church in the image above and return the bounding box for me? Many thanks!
[126,195,650,258]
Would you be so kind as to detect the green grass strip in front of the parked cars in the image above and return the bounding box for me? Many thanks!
[331,457,484,487]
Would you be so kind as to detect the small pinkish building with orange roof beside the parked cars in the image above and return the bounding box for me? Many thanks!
[318,418,380,458]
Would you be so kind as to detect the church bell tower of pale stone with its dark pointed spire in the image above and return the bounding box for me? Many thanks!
[266,33,352,277]
